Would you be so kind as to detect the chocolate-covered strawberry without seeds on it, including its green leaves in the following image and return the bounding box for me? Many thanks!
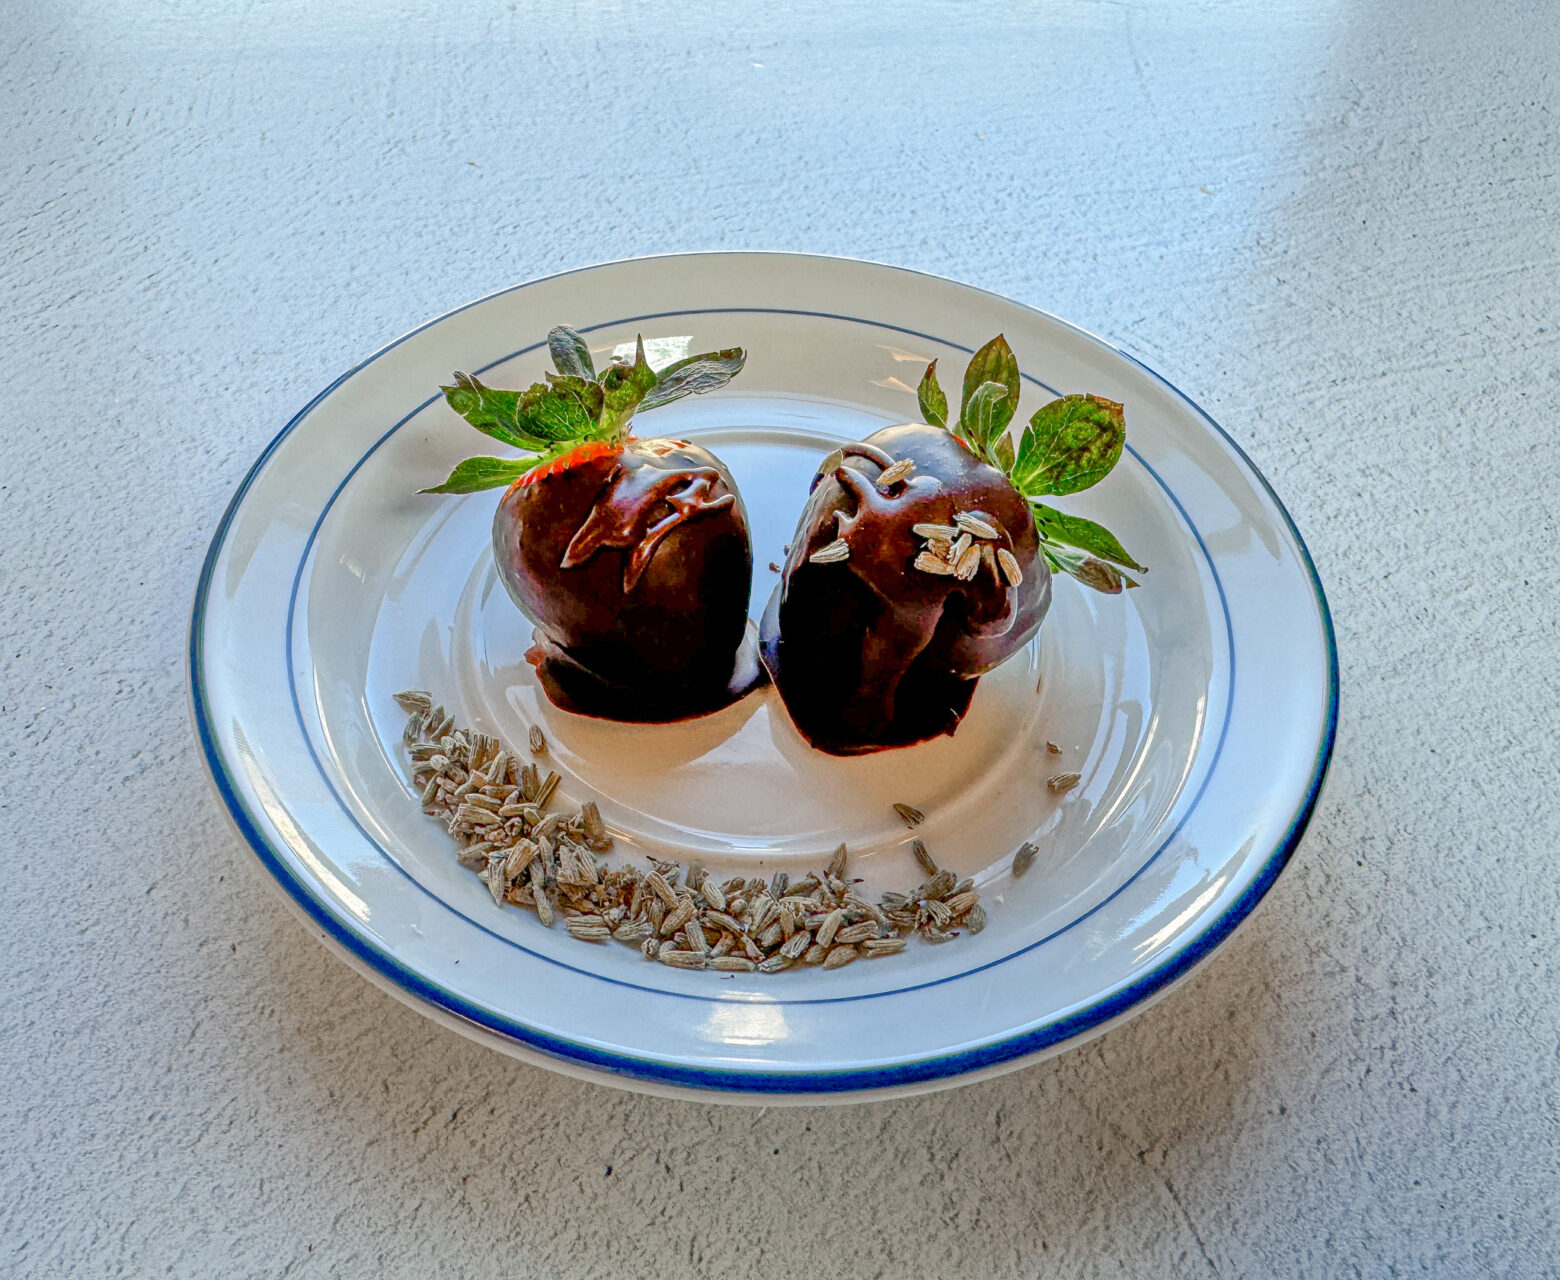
[426,327,761,720]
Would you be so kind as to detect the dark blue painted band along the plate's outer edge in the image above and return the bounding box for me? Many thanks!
[189,254,1338,1094]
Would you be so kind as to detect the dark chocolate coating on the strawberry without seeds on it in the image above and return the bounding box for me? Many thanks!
[493,440,763,722]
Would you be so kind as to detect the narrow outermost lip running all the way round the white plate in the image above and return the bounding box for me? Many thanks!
[186,249,1338,1101]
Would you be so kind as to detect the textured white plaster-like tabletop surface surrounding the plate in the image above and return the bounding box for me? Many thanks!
[0,0,1560,1278]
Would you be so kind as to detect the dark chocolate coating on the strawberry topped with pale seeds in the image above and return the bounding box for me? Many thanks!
[760,424,1051,756]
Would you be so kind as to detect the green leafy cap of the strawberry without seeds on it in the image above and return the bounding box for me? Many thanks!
[423,324,747,493]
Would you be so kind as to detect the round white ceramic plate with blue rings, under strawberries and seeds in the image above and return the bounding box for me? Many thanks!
[190,253,1337,1102]
